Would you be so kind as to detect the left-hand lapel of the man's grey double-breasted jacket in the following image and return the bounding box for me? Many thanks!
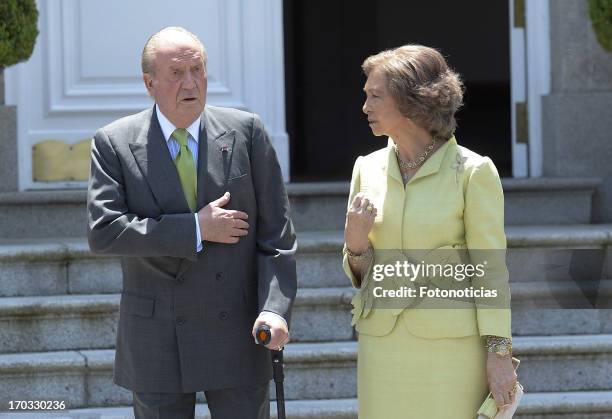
[129,108,189,214]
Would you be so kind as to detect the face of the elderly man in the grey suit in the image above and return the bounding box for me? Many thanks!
[143,34,208,128]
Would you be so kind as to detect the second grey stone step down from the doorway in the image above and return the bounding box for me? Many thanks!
[0,224,612,297]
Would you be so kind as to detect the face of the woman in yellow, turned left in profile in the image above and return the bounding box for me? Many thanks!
[362,69,409,138]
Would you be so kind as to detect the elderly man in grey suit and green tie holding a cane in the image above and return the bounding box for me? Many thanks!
[87,27,297,419]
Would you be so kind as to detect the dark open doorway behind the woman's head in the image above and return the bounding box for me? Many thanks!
[283,0,512,182]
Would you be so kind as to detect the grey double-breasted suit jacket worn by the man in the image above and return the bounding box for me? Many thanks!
[87,106,297,393]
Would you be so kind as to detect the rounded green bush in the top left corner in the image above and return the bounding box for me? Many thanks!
[0,0,38,68]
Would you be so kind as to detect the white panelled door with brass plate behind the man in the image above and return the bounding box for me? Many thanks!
[5,0,289,190]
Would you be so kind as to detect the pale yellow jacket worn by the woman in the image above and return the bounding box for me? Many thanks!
[343,137,511,338]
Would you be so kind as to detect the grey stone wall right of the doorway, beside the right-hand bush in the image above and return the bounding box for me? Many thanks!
[542,0,612,222]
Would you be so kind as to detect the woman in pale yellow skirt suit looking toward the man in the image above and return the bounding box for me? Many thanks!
[343,45,517,419]
